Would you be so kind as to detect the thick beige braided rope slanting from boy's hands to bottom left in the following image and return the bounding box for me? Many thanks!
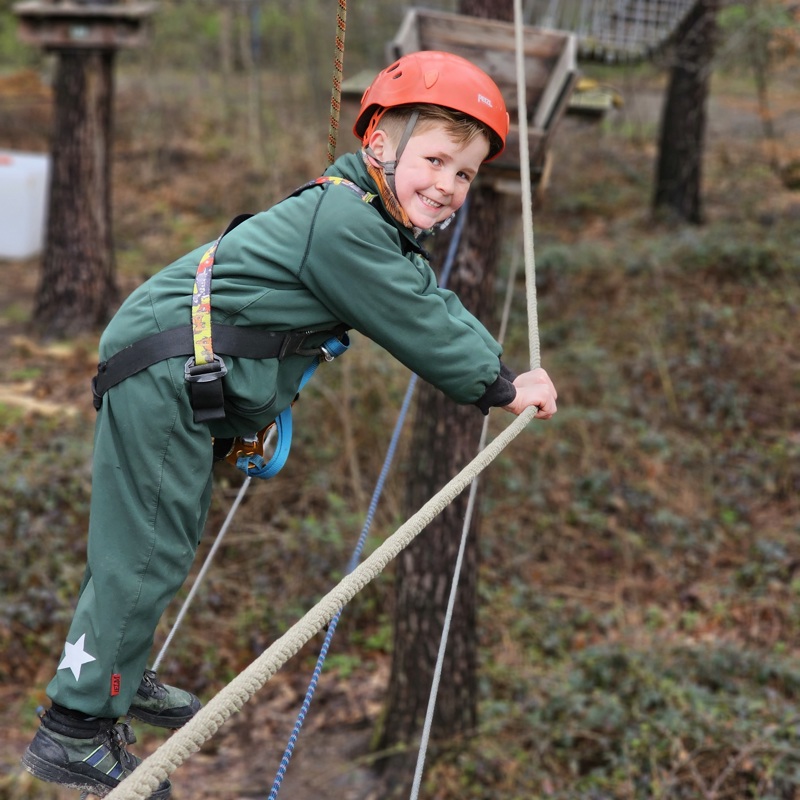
[103,407,536,800]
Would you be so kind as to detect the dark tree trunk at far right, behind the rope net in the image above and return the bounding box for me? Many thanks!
[653,0,719,224]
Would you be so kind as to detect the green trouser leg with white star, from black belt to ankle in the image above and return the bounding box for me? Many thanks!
[47,359,213,717]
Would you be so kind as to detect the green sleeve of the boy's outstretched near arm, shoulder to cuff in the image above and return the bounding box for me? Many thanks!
[299,187,504,403]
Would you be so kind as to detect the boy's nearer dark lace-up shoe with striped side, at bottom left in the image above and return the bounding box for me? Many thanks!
[22,720,172,800]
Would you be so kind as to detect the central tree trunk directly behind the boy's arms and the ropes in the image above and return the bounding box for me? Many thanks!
[377,175,502,798]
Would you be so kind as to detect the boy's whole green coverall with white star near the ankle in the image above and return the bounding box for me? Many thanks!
[47,154,515,717]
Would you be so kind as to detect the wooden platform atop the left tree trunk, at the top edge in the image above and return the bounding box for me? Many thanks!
[13,0,156,50]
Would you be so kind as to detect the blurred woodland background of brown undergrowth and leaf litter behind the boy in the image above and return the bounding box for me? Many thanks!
[0,0,800,800]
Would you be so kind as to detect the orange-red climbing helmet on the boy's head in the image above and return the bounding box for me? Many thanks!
[353,50,508,161]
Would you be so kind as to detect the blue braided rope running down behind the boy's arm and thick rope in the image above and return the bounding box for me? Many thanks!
[269,197,467,800]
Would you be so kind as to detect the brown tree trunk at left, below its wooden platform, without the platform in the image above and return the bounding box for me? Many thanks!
[36,50,117,336]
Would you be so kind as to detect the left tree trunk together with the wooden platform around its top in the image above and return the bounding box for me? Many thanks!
[13,0,156,336]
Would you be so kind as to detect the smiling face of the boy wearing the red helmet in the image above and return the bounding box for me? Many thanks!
[370,125,489,230]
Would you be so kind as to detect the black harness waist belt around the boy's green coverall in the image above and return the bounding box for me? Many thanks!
[92,323,347,409]
